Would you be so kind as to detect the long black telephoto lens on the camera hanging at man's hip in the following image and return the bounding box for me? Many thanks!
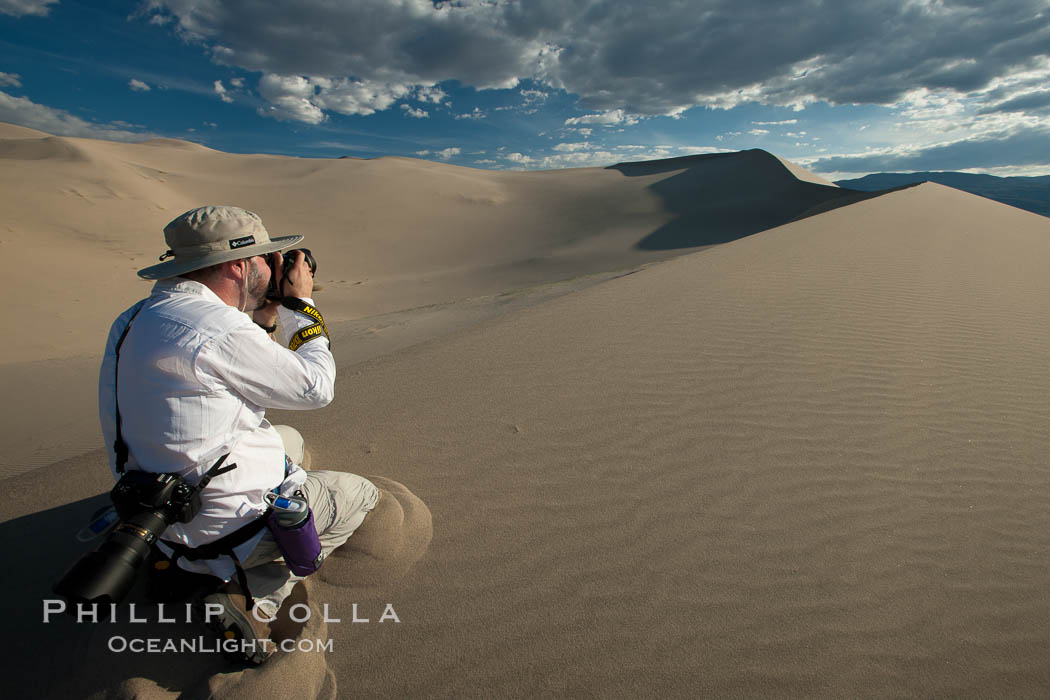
[51,511,168,611]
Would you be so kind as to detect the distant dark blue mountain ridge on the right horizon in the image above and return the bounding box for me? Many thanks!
[835,172,1050,216]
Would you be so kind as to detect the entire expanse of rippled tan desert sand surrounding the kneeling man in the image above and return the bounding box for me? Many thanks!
[0,123,1050,698]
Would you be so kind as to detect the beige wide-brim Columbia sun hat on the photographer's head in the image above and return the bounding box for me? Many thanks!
[139,207,303,279]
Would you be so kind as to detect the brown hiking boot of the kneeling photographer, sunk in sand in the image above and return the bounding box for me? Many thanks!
[196,582,276,665]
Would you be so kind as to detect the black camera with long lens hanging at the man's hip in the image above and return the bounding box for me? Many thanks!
[51,471,201,604]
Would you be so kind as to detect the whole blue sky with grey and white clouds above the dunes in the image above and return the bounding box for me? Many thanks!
[0,0,1050,178]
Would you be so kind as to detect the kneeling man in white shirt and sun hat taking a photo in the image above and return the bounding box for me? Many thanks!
[99,207,379,663]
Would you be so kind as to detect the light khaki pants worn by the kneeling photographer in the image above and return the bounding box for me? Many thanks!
[242,471,379,611]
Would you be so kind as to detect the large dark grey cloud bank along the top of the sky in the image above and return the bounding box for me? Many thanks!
[145,0,1050,114]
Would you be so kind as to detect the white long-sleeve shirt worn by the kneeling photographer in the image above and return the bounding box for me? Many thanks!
[99,277,336,577]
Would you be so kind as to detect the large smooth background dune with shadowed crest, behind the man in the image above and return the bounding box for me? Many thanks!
[0,125,872,474]
